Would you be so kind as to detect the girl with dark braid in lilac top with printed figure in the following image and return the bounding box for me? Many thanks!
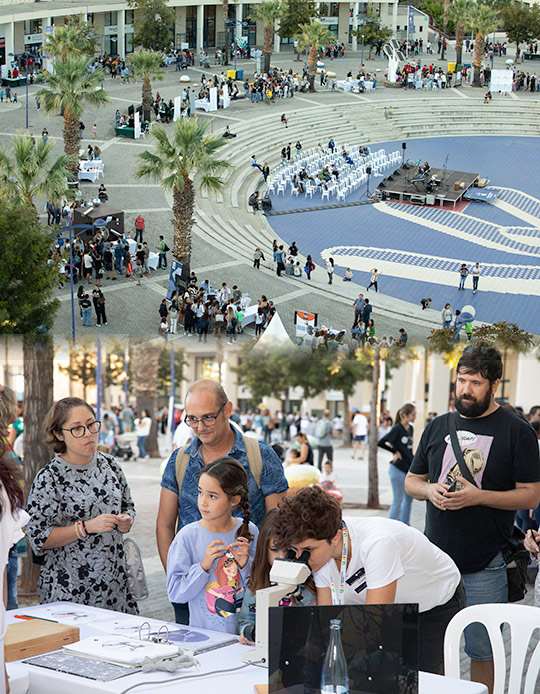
[167,456,258,634]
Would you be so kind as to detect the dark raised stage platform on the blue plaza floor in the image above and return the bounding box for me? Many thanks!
[375,164,479,209]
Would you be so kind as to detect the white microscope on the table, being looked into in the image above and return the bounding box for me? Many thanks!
[242,550,311,667]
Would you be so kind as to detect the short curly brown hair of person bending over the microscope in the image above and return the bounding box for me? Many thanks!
[274,487,342,549]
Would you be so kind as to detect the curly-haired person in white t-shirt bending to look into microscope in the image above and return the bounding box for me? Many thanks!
[275,486,465,674]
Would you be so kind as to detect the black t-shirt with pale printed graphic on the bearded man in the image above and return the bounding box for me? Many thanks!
[410,407,540,573]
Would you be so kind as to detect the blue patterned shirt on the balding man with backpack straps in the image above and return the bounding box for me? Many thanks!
[161,427,289,528]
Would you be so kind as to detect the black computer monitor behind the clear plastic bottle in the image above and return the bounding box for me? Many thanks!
[268,604,418,694]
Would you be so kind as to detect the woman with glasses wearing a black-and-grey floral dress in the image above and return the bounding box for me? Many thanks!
[25,398,137,614]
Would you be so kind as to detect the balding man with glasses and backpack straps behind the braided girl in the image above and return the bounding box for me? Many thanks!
[156,379,288,624]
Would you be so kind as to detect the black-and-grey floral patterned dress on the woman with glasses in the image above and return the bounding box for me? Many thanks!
[25,451,138,614]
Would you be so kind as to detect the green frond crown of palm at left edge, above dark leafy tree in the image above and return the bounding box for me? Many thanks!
[0,135,73,213]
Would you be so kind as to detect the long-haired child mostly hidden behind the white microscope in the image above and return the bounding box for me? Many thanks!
[238,509,316,645]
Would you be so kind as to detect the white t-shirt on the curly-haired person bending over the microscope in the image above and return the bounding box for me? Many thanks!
[314,516,461,612]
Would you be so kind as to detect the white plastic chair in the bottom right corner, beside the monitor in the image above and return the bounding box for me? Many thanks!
[444,603,540,694]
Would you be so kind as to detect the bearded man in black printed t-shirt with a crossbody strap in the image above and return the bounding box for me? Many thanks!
[405,343,540,691]
